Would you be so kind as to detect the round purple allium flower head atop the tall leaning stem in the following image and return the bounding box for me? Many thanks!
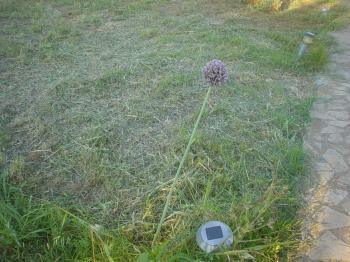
[203,59,228,85]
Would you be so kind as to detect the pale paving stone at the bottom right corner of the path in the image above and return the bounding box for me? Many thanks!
[309,231,350,262]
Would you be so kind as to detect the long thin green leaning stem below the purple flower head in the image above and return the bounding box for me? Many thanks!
[152,86,211,247]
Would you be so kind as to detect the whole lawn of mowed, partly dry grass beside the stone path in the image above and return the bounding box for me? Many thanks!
[0,0,346,261]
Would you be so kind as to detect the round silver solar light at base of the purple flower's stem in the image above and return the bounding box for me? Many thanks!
[196,221,233,253]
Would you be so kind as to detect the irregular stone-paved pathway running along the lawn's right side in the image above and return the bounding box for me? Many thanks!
[301,24,350,262]
